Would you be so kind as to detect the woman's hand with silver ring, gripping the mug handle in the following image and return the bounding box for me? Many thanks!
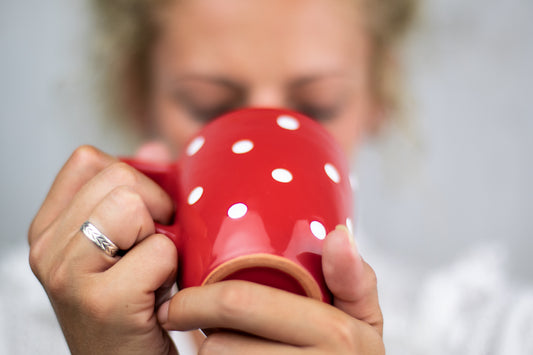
[28,146,177,354]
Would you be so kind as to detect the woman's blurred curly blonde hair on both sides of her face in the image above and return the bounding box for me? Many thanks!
[91,0,417,130]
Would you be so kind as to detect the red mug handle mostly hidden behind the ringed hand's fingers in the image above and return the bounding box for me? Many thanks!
[119,157,179,247]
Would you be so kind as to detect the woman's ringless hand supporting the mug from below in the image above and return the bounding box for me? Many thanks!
[158,228,385,355]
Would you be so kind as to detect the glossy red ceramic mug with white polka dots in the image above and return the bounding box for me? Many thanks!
[123,108,353,302]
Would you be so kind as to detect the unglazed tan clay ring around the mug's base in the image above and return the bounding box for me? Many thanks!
[202,254,322,301]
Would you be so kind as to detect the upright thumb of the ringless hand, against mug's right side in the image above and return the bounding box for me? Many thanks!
[322,226,383,334]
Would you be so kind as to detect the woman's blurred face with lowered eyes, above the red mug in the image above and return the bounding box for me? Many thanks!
[150,0,377,157]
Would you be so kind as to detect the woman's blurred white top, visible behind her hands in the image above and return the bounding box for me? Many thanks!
[0,245,533,355]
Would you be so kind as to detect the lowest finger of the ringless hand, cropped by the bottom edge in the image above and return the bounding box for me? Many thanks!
[198,331,304,355]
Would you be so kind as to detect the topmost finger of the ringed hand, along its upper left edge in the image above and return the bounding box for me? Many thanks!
[28,146,117,244]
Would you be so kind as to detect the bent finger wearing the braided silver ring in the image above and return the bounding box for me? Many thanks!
[66,186,155,272]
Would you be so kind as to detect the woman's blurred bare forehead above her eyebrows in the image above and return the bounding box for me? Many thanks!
[156,0,366,77]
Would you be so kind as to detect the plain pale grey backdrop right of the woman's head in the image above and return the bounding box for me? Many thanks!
[359,0,533,282]
